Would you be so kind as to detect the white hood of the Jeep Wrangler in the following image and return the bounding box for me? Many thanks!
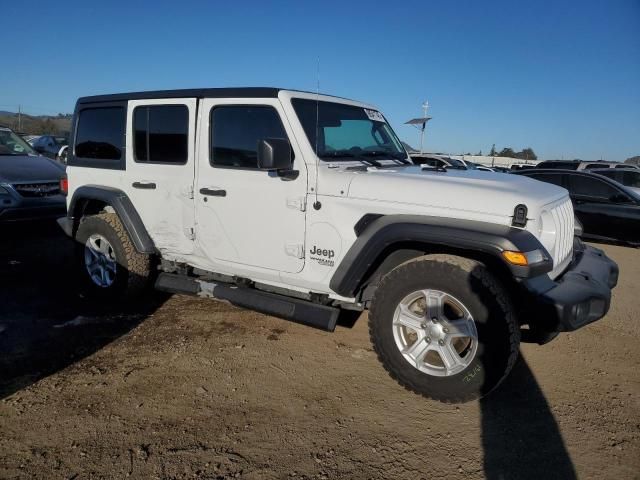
[345,166,567,217]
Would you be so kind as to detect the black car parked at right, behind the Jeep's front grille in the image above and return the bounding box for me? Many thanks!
[516,169,640,246]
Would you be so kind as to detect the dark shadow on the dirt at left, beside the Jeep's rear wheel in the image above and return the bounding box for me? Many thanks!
[0,224,166,399]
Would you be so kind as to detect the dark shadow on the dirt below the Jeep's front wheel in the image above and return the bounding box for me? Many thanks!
[480,356,577,480]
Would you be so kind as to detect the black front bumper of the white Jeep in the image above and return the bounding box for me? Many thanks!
[523,238,618,332]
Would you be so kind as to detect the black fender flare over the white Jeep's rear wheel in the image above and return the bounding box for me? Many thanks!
[59,185,157,254]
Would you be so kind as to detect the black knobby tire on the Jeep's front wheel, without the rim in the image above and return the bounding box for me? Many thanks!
[369,254,520,403]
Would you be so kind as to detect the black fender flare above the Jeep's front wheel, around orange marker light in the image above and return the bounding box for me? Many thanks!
[329,215,553,297]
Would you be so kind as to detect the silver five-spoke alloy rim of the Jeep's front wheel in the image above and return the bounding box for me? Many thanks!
[393,290,478,377]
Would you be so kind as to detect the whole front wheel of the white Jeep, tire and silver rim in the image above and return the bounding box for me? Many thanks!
[369,255,520,403]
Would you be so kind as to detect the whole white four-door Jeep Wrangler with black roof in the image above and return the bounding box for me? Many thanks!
[60,88,618,402]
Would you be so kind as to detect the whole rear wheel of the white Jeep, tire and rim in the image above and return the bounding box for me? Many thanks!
[76,213,152,298]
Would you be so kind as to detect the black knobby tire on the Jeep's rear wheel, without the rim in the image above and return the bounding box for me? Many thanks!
[75,213,152,300]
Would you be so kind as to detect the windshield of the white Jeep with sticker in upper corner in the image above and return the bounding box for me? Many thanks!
[292,98,407,161]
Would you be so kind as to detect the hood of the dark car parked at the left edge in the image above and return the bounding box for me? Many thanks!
[0,155,64,183]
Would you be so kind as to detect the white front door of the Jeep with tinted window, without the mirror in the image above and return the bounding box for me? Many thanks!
[195,99,307,273]
